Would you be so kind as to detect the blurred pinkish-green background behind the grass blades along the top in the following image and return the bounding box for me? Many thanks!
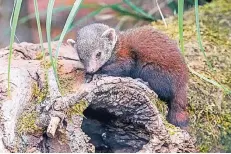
[0,0,211,47]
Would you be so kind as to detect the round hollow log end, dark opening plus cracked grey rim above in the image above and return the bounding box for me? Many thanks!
[76,77,159,152]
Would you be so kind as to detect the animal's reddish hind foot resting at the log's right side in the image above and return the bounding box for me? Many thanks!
[167,110,189,130]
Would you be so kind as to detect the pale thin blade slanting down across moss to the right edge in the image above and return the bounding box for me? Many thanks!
[188,67,231,94]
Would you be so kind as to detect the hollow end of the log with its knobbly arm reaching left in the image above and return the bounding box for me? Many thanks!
[38,70,195,152]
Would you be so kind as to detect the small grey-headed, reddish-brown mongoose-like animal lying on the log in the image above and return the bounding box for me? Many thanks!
[68,23,188,128]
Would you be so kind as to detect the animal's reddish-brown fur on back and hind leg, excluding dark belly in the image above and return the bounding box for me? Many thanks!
[111,26,188,127]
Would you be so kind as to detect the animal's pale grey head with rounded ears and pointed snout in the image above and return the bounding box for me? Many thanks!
[69,24,117,73]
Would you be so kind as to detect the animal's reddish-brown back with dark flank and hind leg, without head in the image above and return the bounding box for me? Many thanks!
[118,26,188,127]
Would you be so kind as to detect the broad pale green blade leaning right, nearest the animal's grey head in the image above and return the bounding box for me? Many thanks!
[55,0,82,64]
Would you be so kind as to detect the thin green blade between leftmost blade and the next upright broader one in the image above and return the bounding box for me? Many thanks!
[34,0,45,59]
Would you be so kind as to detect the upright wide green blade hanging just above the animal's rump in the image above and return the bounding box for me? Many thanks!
[178,0,184,55]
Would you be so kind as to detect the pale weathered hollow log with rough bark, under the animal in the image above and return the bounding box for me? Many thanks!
[0,43,195,152]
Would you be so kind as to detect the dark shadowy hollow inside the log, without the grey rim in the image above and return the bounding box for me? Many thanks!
[81,105,150,153]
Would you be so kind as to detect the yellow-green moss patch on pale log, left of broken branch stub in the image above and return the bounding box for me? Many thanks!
[17,111,42,134]
